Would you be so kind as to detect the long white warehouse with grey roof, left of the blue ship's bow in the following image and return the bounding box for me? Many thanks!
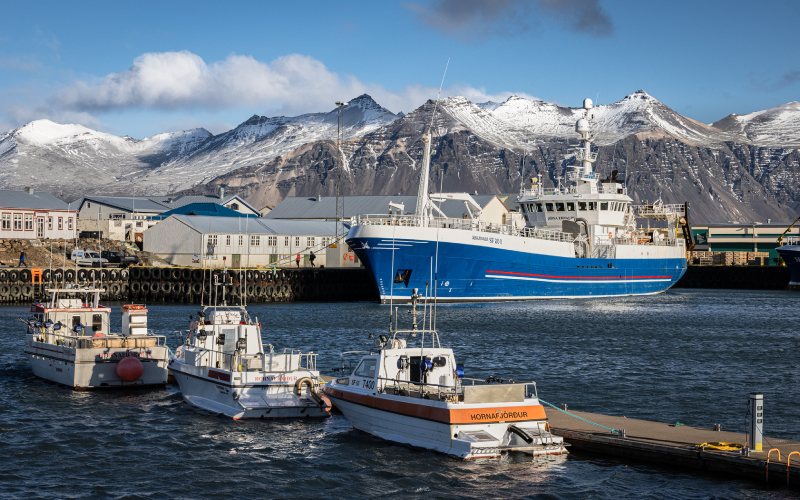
[144,215,360,268]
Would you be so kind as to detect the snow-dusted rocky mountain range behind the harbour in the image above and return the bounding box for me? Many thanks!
[0,91,800,222]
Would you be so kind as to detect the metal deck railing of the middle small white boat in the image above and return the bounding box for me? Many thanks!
[181,347,317,373]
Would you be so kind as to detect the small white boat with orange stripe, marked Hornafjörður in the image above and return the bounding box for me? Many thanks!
[324,290,567,459]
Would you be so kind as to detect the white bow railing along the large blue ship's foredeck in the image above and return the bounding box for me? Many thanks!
[352,214,575,243]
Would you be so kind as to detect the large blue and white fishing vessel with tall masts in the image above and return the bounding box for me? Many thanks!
[346,99,688,302]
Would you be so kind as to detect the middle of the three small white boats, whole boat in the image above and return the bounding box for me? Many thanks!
[169,273,330,420]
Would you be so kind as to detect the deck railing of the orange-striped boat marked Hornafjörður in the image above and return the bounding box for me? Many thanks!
[378,377,538,403]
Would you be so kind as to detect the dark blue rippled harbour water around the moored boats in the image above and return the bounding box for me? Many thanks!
[0,290,800,498]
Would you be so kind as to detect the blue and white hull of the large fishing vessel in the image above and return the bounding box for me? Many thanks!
[347,225,686,302]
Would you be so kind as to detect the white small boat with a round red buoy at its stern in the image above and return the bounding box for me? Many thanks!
[23,287,169,389]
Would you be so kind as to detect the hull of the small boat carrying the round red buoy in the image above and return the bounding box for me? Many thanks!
[25,341,168,389]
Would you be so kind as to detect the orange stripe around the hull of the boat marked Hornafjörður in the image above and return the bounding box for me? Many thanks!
[325,387,547,425]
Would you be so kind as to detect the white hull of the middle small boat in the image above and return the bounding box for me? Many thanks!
[169,360,330,420]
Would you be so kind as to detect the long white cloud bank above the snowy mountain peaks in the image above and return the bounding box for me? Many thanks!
[53,51,532,115]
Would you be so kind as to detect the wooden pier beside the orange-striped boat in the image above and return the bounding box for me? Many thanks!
[547,408,800,489]
